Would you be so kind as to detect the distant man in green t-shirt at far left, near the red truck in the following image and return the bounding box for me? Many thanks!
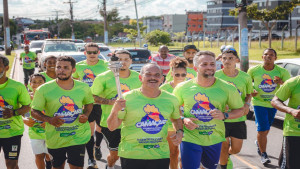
[20,45,38,87]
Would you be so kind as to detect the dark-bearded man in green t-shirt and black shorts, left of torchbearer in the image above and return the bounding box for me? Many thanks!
[31,56,94,169]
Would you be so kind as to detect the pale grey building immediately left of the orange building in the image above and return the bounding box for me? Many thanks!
[162,14,187,33]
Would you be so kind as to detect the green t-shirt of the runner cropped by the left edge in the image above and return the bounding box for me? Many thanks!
[0,78,31,138]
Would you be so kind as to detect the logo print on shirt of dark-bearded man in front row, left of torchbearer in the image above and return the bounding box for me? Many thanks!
[54,96,82,124]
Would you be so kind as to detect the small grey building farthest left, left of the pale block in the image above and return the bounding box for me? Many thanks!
[143,16,163,33]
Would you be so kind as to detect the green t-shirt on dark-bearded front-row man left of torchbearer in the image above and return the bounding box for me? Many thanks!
[31,80,94,149]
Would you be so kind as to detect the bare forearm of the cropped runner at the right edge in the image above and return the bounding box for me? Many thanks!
[271,96,300,119]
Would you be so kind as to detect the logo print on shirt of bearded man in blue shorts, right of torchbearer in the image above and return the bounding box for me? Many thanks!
[190,93,215,122]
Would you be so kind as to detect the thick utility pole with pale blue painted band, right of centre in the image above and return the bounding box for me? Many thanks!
[235,0,249,72]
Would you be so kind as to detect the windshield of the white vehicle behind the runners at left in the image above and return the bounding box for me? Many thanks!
[44,43,77,52]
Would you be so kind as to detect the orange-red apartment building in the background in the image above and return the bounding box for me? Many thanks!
[187,11,207,35]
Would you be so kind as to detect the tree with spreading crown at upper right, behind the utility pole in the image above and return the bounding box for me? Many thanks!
[229,0,300,48]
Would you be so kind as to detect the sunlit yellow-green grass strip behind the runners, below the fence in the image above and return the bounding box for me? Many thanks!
[109,39,300,60]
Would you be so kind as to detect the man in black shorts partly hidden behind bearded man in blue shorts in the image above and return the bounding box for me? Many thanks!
[215,47,253,169]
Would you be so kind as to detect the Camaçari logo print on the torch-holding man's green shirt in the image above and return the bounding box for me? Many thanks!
[135,104,168,134]
